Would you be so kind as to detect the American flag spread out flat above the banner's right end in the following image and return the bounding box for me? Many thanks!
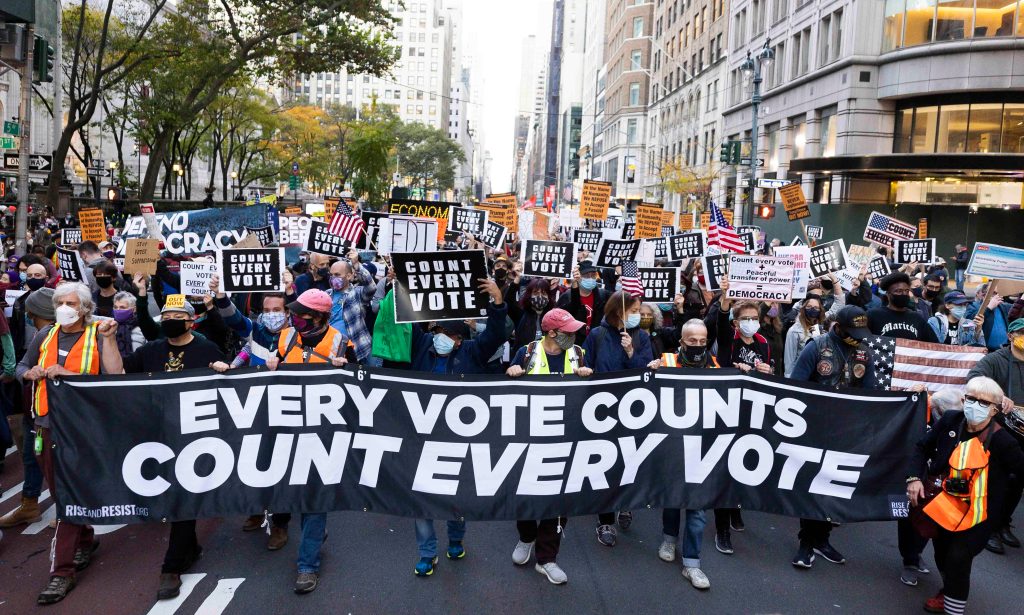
[865,337,986,392]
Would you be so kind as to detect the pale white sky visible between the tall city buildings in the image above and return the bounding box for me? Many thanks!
[463,0,551,192]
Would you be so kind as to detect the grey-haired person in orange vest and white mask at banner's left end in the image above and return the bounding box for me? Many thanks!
[15,282,124,605]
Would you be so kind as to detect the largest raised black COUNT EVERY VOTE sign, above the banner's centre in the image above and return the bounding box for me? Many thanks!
[391,250,490,322]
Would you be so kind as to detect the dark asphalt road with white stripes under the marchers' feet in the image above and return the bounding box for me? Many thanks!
[0,442,1024,615]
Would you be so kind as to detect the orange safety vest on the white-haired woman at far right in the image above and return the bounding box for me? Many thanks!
[925,426,998,532]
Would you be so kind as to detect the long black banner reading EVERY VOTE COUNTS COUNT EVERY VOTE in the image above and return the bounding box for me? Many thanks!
[47,365,925,524]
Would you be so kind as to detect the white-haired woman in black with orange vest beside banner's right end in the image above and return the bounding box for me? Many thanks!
[906,377,1024,615]
